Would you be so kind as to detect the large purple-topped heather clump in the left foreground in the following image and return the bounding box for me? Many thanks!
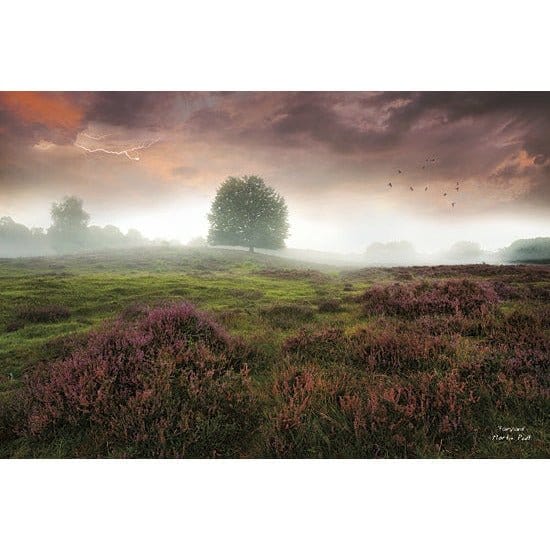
[25,303,256,457]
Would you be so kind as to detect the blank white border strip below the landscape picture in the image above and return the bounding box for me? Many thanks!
[0,460,549,550]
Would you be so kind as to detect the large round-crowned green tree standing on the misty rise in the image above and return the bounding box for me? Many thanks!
[208,176,289,252]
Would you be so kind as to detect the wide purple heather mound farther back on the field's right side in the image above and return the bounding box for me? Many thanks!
[360,279,499,318]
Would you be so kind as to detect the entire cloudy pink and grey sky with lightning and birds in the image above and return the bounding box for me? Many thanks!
[0,92,550,252]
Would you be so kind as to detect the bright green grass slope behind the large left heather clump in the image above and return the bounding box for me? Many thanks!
[0,248,358,389]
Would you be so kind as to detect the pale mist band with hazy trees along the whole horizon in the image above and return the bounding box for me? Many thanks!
[0,206,550,266]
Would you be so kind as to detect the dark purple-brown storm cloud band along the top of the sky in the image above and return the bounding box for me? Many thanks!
[0,92,550,163]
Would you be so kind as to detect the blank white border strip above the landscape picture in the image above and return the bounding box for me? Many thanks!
[0,0,549,91]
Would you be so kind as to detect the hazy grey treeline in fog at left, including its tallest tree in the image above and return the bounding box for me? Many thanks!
[0,197,153,258]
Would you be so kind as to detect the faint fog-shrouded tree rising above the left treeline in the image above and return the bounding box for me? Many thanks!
[48,197,90,253]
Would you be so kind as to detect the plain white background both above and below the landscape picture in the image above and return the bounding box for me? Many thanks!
[0,0,550,550]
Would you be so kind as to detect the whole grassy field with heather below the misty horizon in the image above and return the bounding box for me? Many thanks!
[0,248,550,458]
